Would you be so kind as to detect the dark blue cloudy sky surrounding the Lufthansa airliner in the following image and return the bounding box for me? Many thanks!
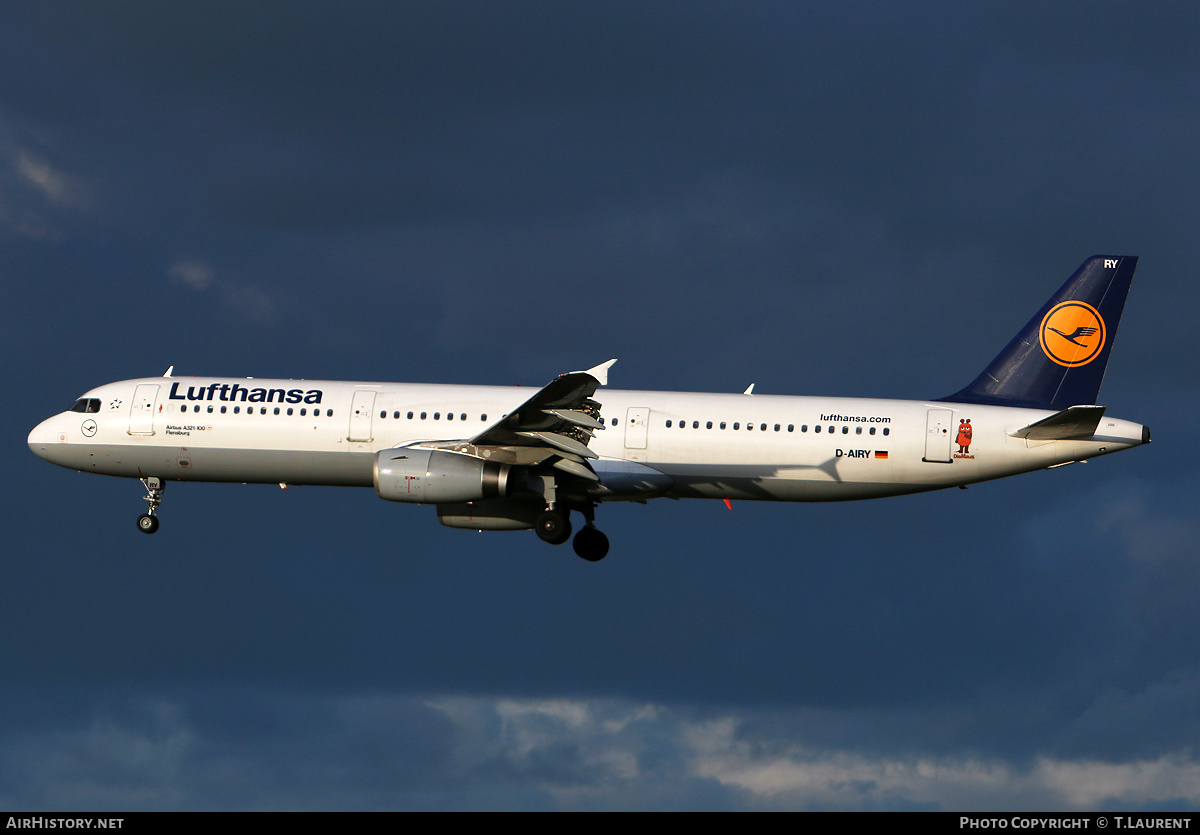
[0,0,1200,810]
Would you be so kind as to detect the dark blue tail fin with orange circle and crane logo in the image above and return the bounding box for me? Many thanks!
[941,256,1138,410]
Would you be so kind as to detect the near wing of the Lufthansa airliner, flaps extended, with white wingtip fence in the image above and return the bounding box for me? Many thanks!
[415,360,617,481]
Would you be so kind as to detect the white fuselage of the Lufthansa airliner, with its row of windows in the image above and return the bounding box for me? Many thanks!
[29,377,1148,501]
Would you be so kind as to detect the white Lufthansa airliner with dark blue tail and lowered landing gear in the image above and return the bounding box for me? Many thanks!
[29,256,1150,561]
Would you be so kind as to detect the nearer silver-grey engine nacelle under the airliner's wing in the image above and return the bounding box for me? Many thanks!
[374,447,516,504]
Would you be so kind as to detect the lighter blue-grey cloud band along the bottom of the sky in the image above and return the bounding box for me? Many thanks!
[0,690,1200,811]
